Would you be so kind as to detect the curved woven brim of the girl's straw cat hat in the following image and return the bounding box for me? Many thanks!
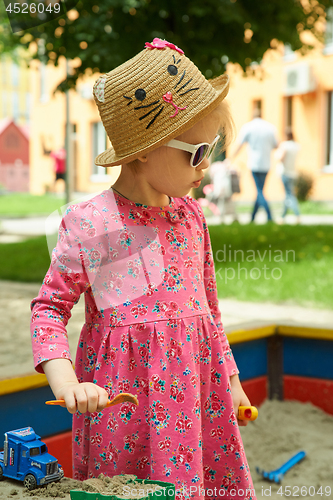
[95,75,229,167]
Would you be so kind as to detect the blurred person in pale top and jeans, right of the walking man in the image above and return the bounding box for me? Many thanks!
[276,128,300,224]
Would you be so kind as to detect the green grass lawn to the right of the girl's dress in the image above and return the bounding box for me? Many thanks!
[209,224,333,308]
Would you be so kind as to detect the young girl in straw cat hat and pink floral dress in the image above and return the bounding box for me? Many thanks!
[31,39,255,500]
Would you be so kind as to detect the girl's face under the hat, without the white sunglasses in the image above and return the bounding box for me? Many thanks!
[140,110,220,198]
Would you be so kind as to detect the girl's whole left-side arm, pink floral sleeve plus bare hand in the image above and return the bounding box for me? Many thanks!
[31,204,108,413]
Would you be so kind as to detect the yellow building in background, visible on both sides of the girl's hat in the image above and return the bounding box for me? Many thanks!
[30,29,333,201]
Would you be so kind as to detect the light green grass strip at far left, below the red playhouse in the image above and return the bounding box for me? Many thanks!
[0,193,66,217]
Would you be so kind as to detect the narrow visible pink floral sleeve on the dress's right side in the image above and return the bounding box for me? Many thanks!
[198,201,239,377]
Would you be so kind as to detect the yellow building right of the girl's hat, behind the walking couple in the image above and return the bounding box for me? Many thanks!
[227,30,333,200]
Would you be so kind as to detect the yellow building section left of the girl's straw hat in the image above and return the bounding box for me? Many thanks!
[30,58,119,194]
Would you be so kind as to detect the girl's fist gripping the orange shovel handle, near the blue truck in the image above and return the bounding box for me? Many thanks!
[56,382,109,413]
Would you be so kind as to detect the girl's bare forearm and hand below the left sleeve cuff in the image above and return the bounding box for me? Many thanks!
[41,358,108,413]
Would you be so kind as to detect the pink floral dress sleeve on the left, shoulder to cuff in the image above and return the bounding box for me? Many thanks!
[30,203,105,373]
